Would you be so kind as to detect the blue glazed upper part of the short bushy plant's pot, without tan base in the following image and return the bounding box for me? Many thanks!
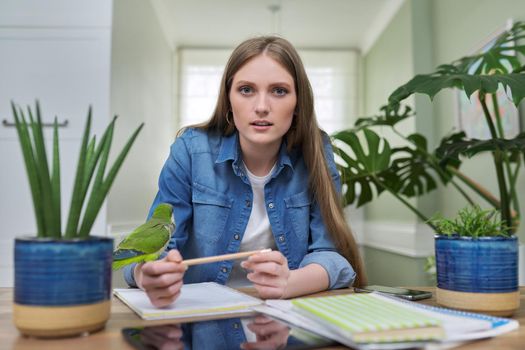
[435,235,518,293]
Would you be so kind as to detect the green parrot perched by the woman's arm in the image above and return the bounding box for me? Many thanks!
[113,203,175,270]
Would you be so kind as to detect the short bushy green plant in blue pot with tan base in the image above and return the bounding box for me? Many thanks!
[431,205,520,316]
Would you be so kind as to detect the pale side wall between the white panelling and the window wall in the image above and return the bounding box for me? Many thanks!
[108,0,176,234]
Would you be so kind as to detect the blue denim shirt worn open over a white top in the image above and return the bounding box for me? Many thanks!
[124,128,355,289]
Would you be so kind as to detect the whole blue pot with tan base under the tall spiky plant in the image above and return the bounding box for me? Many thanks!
[13,237,113,337]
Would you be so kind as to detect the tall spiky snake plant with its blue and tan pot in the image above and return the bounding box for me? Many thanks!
[11,102,143,337]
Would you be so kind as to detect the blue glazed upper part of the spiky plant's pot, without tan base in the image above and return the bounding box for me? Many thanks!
[14,237,113,306]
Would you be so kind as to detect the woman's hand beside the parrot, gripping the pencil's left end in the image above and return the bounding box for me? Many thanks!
[134,249,188,307]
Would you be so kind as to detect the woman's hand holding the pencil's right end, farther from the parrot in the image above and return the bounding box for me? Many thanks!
[241,251,290,299]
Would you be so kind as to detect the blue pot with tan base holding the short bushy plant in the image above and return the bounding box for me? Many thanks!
[435,235,520,316]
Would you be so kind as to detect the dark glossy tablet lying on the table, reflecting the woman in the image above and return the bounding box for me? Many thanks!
[122,315,336,350]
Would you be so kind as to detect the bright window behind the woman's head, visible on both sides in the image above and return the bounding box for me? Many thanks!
[178,48,357,133]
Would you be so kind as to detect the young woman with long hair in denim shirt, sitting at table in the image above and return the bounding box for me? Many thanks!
[124,37,365,307]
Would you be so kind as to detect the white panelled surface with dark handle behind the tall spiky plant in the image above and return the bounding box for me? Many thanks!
[0,0,112,286]
